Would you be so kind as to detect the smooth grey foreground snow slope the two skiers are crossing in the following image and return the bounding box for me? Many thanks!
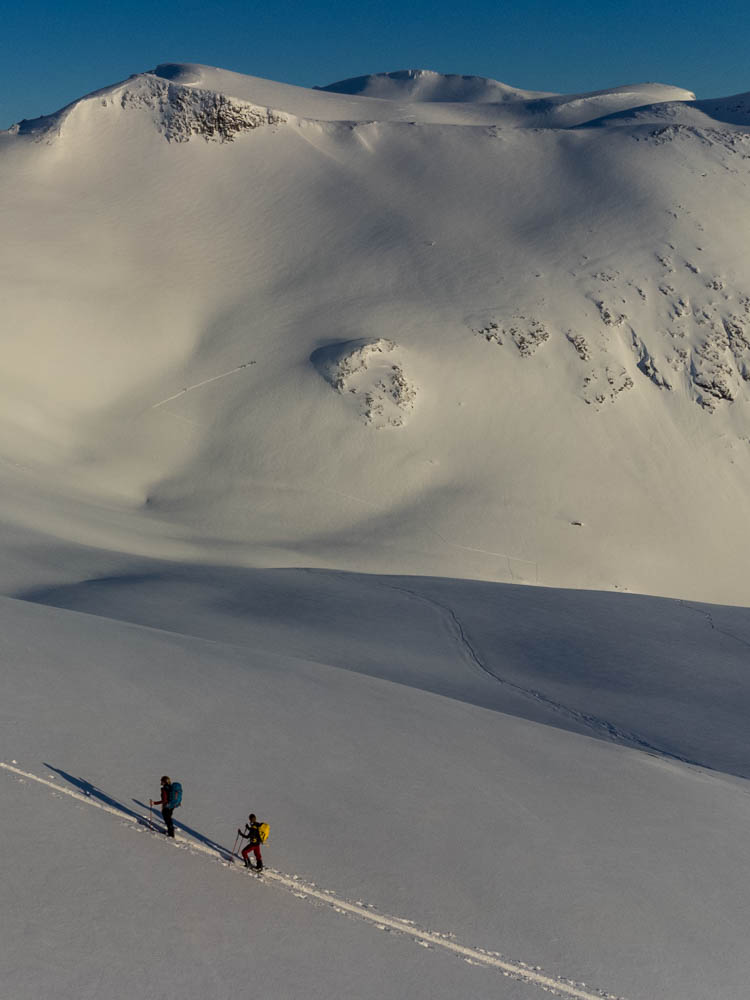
[0,584,750,1000]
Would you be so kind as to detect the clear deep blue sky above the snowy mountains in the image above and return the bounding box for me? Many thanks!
[0,0,750,128]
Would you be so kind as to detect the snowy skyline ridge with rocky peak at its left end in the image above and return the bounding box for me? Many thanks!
[4,63,695,141]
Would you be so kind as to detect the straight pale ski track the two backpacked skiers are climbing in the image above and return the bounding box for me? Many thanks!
[0,761,625,1000]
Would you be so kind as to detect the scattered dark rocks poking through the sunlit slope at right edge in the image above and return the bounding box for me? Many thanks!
[474,247,750,412]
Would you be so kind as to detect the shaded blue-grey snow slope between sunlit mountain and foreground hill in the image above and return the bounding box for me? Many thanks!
[17,560,750,778]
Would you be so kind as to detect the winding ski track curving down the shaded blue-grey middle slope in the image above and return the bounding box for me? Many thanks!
[381,583,712,770]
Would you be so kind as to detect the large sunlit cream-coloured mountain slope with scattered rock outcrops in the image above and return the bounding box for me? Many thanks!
[0,66,750,604]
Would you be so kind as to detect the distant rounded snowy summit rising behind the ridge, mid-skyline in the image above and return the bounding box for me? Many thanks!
[315,69,547,104]
